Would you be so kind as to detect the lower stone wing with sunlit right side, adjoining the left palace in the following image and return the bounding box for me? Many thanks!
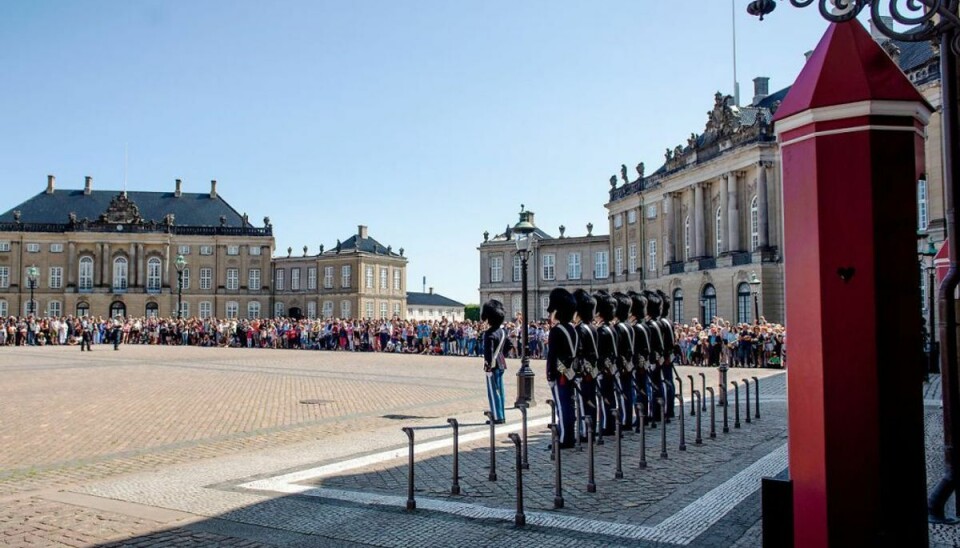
[273,225,407,319]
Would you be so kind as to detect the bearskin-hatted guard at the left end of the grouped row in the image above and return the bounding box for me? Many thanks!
[547,287,578,449]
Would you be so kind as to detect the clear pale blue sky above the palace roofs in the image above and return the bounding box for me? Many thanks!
[0,0,840,303]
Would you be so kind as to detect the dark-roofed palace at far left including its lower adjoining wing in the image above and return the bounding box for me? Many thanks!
[0,175,407,318]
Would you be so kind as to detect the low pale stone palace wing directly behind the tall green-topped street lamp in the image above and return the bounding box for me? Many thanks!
[477,214,613,319]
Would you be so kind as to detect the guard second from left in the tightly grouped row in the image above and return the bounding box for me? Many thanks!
[573,289,600,439]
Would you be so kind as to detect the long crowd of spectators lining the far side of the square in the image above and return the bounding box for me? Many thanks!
[0,316,786,367]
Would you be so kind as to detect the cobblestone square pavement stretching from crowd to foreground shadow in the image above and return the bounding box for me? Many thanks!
[0,347,924,546]
